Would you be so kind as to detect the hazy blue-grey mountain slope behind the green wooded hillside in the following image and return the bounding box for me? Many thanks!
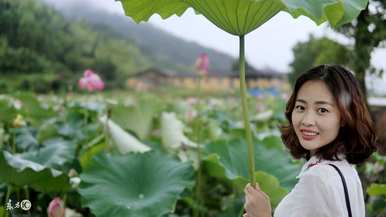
[41,0,235,74]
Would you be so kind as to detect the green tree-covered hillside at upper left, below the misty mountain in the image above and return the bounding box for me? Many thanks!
[0,0,150,92]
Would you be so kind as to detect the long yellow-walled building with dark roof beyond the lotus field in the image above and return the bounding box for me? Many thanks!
[127,67,289,93]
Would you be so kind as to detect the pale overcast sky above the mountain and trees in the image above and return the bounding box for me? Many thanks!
[47,0,386,94]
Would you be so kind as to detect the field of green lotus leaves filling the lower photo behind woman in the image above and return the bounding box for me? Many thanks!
[0,90,386,217]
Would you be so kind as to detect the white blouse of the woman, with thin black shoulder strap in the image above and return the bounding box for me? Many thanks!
[274,156,365,217]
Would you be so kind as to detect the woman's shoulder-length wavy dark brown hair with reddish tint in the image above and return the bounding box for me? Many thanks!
[281,65,378,164]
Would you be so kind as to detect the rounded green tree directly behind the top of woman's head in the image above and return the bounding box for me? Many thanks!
[288,35,351,85]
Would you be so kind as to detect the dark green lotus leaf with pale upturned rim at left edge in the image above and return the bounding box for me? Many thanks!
[0,151,70,192]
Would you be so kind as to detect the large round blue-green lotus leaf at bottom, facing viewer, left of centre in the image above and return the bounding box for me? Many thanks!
[79,152,193,217]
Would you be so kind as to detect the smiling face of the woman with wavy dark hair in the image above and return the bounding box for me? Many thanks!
[292,80,340,154]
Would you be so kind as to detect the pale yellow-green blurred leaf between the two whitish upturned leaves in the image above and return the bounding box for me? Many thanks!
[111,101,156,139]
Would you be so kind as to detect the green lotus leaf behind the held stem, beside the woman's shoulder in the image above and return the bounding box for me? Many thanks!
[205,137,300,189]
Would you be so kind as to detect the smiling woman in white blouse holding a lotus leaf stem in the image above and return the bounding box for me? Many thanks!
[244,65,377,217]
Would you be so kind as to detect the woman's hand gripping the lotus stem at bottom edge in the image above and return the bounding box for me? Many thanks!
[243,183,272,217]
